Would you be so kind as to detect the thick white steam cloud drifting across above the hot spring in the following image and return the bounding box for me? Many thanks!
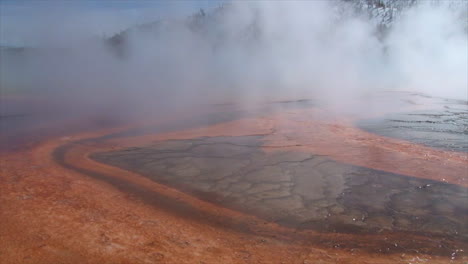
[0,1,468,120]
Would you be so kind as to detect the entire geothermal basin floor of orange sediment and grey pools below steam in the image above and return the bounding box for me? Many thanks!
[0,93,468,263]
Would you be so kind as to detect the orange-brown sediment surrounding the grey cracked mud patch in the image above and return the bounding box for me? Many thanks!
[0,104,467,263]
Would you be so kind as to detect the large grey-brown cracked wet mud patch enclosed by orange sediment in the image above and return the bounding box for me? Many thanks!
[91,136,468,240]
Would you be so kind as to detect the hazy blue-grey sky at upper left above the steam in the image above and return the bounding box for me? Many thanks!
[0,0,226,46]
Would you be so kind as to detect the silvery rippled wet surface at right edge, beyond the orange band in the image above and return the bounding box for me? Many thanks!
[357,98,468,152]
